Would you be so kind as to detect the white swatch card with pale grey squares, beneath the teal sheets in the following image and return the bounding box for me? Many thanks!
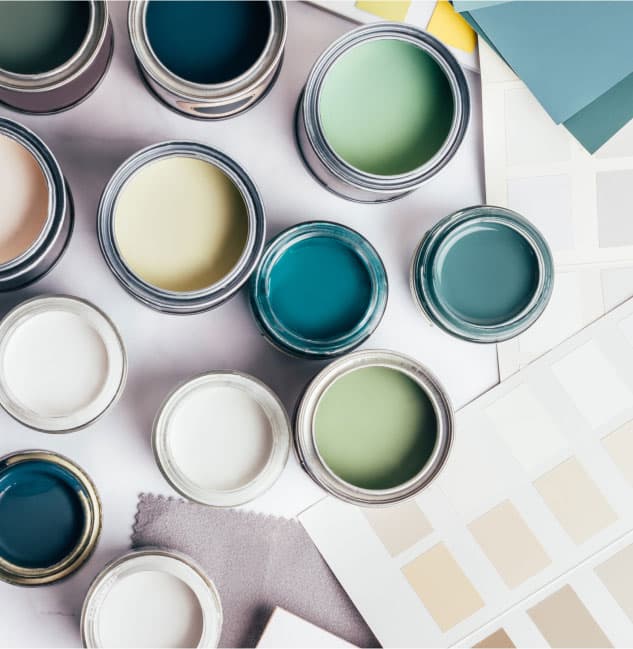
[479,42,633,379]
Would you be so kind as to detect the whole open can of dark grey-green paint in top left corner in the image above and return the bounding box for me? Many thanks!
[0,0,113,113]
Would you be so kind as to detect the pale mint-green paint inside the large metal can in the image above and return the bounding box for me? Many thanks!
[319,38,455,176]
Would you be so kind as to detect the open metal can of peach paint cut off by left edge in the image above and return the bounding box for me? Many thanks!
[0,117,73,291]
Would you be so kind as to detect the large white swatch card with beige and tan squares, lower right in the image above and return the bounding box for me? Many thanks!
[300,300,633,647]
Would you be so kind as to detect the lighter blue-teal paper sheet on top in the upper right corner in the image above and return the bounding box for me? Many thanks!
[462,0,633,123]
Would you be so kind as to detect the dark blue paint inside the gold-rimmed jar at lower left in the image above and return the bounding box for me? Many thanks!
[0,460,86,568]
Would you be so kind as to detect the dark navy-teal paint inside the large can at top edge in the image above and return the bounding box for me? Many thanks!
[145,0,272,84]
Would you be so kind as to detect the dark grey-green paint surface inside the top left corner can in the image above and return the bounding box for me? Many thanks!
[0,0,90,74]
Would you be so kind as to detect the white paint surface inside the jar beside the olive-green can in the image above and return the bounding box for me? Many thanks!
[167,385,273,491]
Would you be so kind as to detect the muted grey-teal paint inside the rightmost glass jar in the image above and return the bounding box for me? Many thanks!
[433,221,539,325]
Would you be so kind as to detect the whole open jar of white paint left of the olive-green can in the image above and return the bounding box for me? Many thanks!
[152,371,291,507]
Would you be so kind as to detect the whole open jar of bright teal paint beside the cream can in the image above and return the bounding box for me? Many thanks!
[250,221,388,358]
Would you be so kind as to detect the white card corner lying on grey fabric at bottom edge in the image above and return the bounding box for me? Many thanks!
[257,606,354,649]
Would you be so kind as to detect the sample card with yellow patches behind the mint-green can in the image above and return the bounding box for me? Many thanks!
[308,0,479,72]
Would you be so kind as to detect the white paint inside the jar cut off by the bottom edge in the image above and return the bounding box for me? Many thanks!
[97,570,203,647]
